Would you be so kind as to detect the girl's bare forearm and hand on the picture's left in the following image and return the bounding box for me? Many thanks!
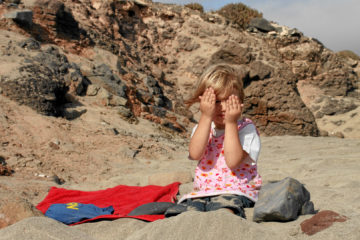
[189,88,216,160]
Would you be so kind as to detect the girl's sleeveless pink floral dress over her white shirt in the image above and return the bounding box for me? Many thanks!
[179,118,262,202]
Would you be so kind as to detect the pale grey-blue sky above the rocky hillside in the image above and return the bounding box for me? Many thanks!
[153,0,360,56]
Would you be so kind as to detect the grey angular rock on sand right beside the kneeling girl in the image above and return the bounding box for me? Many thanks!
[253,177,315,222]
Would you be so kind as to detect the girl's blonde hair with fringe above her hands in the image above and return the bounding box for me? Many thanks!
[185,64,245,107]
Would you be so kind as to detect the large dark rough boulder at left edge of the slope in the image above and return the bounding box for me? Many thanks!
[0,46,70,116]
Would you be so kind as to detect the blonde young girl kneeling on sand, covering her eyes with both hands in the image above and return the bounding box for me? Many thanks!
[165,64,261,218]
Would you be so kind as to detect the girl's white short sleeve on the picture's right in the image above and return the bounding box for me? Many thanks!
[239,124,261,163]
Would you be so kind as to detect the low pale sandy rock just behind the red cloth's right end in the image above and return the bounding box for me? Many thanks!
[148,171,192,186]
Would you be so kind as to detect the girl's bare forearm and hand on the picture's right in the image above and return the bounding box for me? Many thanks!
[224,95,248,169]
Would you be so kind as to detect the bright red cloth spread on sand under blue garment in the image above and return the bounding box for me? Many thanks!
[36,182,180,225]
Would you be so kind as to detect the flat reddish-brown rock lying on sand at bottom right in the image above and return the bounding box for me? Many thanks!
[300,210,348,236]
